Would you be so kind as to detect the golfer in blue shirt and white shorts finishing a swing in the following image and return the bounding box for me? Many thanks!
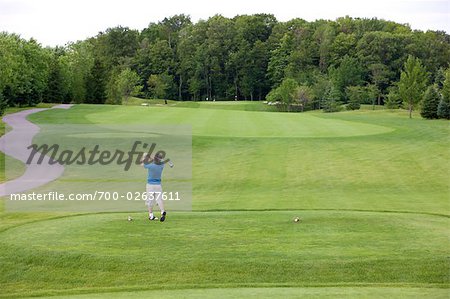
[142,152,173,222]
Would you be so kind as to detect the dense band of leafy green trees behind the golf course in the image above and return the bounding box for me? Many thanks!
[0,14,450,118]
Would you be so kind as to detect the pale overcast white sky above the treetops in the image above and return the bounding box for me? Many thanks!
[0,0,450,47]
